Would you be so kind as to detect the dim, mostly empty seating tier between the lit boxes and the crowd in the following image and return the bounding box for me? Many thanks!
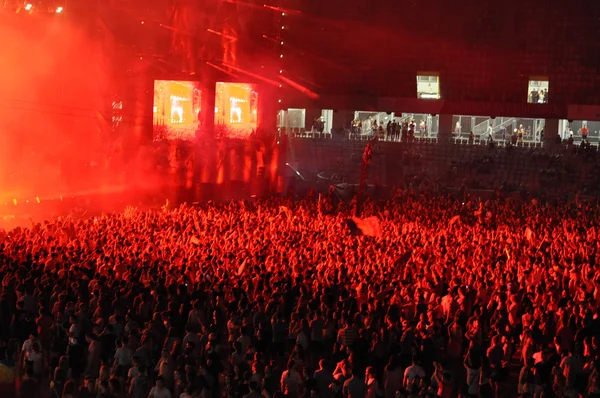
[290,138,600,194]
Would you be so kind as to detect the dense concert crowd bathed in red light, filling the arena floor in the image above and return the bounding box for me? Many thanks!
[0,192,600,398]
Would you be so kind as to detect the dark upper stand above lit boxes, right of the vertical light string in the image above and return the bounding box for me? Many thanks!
[285,0,600,102]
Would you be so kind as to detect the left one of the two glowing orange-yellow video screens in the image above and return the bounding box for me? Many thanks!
[153,80,202,141]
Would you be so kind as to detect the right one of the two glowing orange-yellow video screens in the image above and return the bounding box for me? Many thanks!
[215,82,258,138]
